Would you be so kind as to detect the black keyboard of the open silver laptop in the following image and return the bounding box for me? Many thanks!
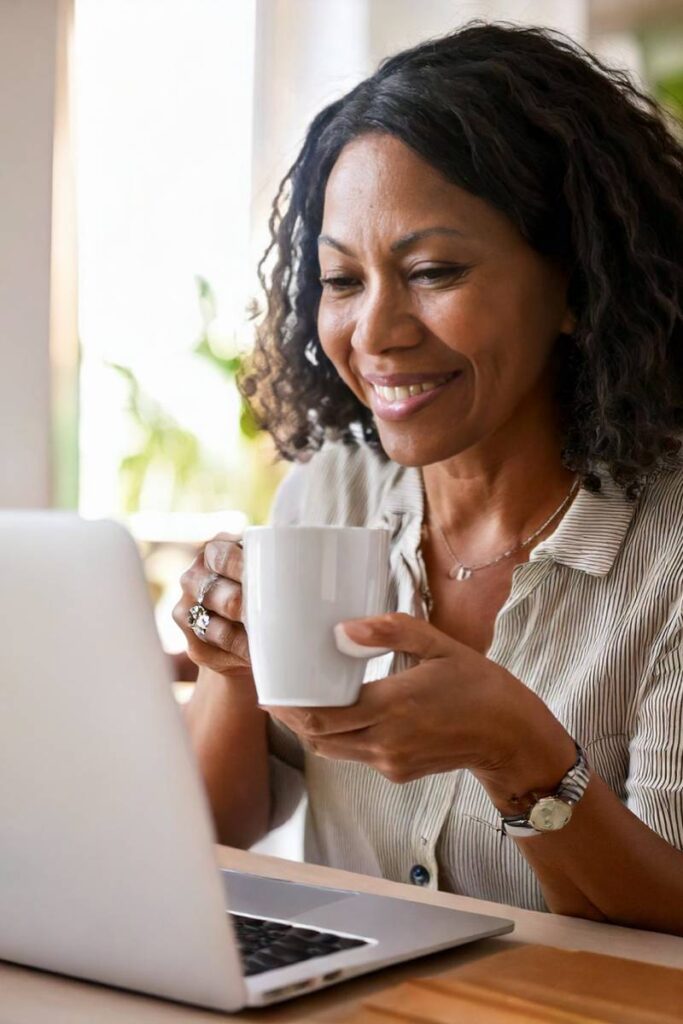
[230,913,369,975]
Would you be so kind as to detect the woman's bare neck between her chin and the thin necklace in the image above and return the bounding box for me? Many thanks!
[422,399,574,560]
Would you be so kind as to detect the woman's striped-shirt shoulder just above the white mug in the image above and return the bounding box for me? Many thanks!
[270,441,403,526]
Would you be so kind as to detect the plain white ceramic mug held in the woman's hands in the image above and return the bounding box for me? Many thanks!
[242,526,389,708]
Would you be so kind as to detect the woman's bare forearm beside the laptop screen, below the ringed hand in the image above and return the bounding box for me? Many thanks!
[183,669,270,849]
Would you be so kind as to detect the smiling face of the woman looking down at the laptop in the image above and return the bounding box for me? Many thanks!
[317,134,574,466]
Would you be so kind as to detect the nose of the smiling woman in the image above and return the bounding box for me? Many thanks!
[351,284,422,355]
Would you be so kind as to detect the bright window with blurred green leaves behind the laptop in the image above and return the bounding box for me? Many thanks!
[75,0,284,649]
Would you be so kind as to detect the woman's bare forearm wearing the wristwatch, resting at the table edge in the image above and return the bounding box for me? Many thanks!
[474,671,683,935]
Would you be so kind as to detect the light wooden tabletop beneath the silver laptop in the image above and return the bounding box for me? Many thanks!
[0,847,683,1024]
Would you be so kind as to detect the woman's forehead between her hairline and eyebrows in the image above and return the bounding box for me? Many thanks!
[323,133,498,241]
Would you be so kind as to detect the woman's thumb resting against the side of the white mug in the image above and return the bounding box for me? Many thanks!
[335,611,461,659]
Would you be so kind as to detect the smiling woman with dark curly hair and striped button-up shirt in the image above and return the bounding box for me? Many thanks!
[175,23,683,934]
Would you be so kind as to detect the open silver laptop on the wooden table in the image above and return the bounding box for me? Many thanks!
[0,512,513,1011]
